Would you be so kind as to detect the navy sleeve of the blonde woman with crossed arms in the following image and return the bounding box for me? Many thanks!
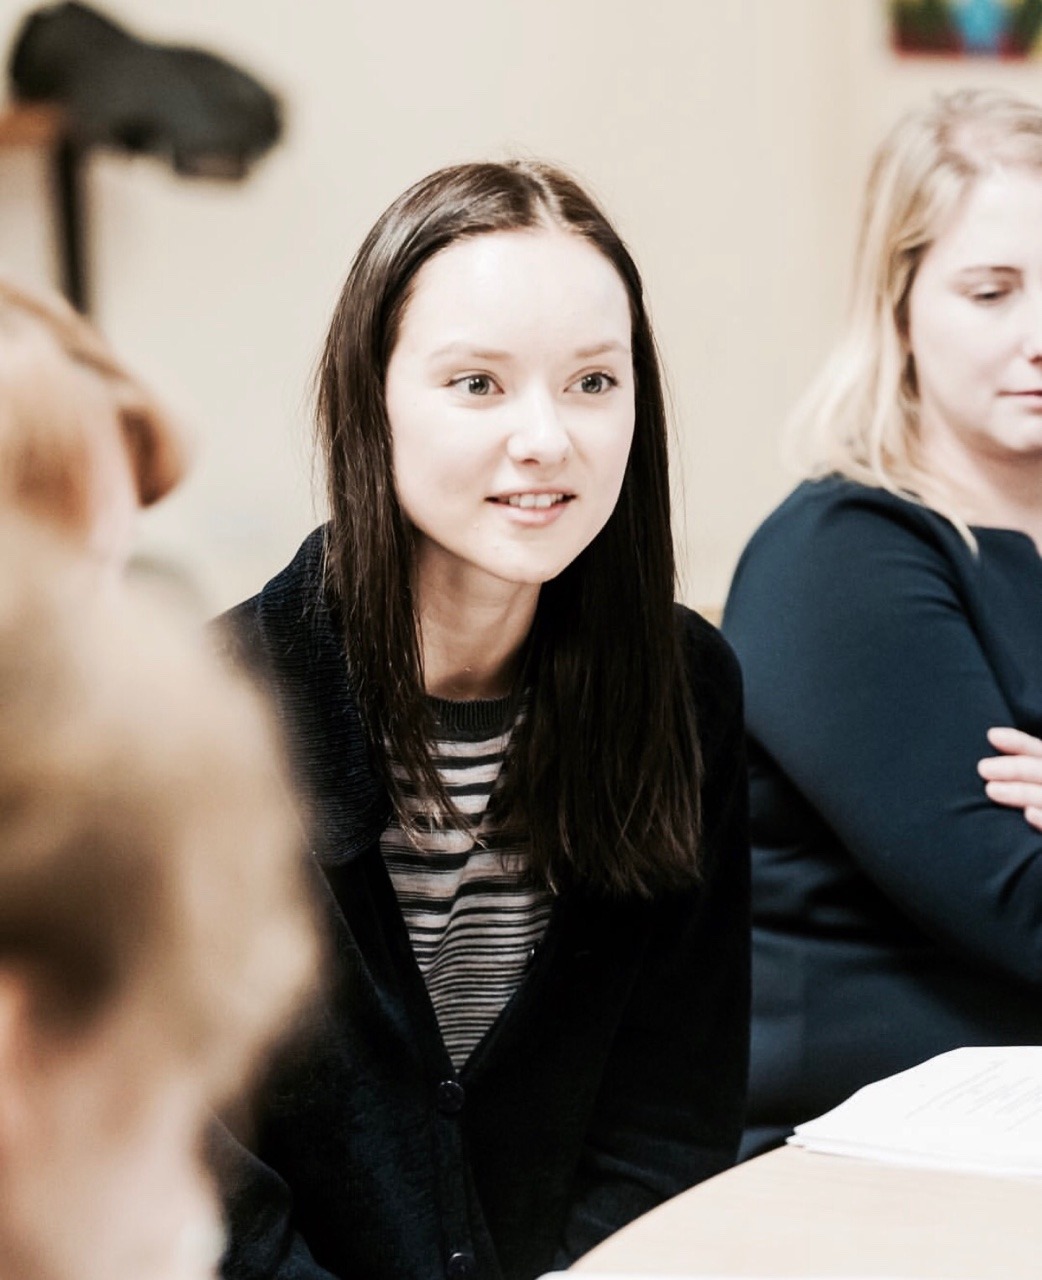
[725,492,1042,988]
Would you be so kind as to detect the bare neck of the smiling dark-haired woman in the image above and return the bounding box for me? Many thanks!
[417,572,539,700]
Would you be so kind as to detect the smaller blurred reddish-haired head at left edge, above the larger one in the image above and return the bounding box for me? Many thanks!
[0,278,186,567]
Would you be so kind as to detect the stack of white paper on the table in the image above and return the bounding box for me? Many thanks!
[789,1044,1042,1176]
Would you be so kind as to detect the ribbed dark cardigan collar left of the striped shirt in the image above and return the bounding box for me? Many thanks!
[257,526,390,865]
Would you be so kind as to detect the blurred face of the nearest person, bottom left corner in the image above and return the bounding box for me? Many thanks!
[0,988,220,1280]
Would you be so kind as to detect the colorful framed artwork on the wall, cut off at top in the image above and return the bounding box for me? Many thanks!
[887,0,1042,58]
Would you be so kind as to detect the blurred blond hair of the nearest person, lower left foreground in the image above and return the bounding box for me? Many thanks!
[0,518,317,1098]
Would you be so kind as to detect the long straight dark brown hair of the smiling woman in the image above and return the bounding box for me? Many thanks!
[317,161,700,895]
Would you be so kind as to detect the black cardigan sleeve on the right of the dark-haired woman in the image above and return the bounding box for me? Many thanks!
[556,616,749,1267]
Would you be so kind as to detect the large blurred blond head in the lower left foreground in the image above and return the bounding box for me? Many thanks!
[0,518,316,1280]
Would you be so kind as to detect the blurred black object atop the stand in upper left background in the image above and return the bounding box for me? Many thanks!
[9,3,282,178]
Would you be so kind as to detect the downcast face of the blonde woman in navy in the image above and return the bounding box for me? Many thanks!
[908,169,1042,479]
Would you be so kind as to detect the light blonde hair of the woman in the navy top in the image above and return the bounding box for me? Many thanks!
[790,90,1042,529]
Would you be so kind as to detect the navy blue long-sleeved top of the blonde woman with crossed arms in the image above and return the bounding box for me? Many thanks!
[723,477,1042,1153]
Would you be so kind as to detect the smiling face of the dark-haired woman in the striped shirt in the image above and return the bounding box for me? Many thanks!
[387,228,634,604]
